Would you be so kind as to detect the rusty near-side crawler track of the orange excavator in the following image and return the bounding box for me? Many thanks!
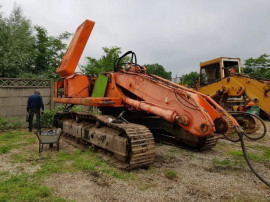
[54,112,155,170]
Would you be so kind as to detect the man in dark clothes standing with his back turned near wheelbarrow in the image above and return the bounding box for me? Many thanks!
[27,90,44,132]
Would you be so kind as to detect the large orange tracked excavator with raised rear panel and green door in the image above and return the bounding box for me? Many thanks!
[54,20,268,185]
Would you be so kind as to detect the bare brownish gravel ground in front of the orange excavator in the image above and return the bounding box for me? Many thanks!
[46,122,270,201]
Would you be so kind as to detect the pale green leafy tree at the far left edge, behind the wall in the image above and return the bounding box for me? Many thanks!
[0,5,34,77]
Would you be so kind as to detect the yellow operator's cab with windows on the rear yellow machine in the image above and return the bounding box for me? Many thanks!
[200,57,242,86]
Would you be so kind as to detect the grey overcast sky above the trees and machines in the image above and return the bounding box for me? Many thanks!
[0,0,270,77]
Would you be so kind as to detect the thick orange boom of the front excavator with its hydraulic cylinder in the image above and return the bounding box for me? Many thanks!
[115,72,222,136]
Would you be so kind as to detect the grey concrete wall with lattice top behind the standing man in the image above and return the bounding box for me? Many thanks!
[0,78,54,127]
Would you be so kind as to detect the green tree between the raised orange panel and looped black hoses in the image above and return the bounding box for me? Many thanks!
[82,46,124,75]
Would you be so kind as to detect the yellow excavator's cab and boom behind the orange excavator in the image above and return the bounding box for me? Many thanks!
[197,57,270,116]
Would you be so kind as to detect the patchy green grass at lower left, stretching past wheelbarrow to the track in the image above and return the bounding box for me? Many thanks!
[0,130,135,202]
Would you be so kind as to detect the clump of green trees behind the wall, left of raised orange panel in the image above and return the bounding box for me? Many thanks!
[0,5,71,79]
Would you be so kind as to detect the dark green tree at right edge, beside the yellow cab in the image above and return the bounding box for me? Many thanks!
[244,54,270,79]
